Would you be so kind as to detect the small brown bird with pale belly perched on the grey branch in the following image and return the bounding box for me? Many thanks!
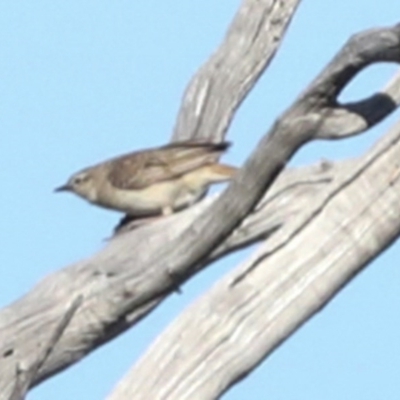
[55,141,237,217]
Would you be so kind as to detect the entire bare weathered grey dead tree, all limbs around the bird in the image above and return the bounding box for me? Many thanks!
[0,0,400,400]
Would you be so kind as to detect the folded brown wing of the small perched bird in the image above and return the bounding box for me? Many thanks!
[109,142,230,190]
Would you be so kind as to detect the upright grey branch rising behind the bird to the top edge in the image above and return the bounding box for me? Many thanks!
[173,0,300,141]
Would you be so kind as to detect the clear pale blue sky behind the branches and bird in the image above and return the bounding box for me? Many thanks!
[0,0,400,400]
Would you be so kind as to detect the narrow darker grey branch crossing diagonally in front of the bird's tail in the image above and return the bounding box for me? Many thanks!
[111,25,400,316]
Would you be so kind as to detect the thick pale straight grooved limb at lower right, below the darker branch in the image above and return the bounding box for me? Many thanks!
[108,123,400,400]
